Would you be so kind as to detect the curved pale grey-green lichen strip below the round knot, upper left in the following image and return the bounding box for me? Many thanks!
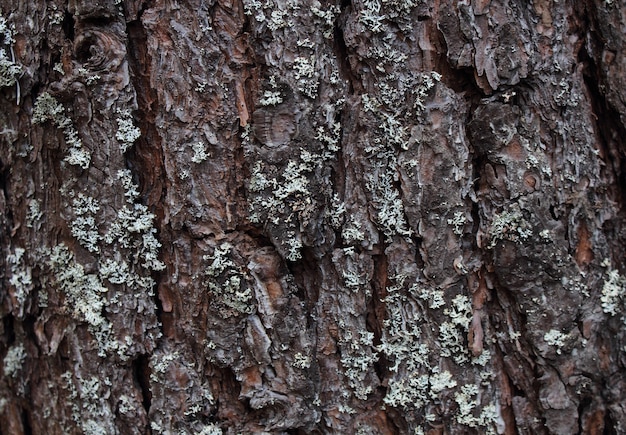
[33,92,91,169]
